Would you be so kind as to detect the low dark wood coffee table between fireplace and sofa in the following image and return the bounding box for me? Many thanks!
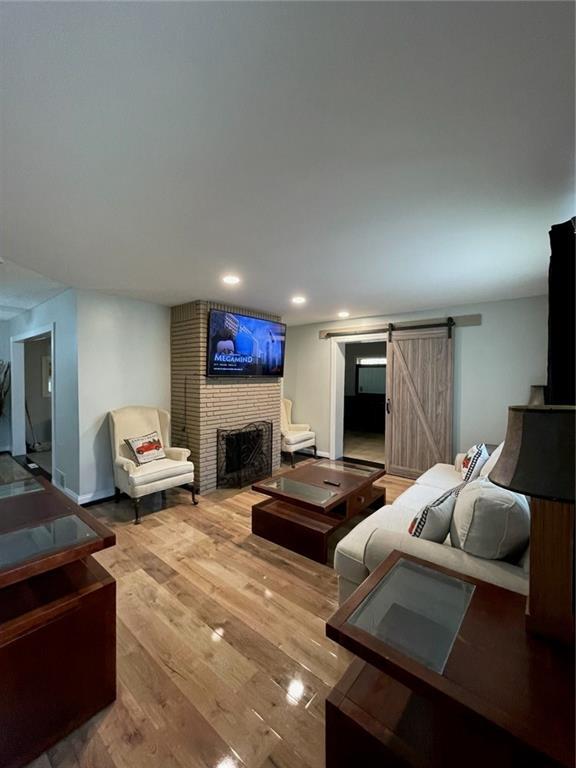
[252,459,386,563]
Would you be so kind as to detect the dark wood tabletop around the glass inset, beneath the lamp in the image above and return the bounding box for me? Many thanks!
[326,552,574,768]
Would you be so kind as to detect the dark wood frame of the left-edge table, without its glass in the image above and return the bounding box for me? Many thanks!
[0,477,116,768]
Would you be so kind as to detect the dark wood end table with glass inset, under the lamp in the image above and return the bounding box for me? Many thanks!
[326,552,574,768]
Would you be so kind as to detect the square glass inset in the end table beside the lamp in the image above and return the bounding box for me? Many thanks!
[347,558,475,674]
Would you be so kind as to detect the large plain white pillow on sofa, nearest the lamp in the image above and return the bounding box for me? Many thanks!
[450,478,530,560]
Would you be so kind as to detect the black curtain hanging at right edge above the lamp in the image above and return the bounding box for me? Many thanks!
[546,219,576,405]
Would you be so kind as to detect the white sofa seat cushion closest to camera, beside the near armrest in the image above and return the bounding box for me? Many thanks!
[334,501,414,584]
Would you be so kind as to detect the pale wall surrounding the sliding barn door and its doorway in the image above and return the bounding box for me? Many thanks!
[284,296,548,451]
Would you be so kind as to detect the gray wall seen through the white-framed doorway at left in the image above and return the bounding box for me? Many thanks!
[24,339,52,444]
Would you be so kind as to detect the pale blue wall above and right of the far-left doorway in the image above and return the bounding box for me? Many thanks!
[9,289,80,494]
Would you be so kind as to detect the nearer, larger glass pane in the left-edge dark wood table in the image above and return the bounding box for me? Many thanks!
[0,515,98,569]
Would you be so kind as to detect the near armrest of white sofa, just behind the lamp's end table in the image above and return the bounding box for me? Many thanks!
[364,528,528,595]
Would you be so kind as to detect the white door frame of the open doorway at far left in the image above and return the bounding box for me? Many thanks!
[10,323,57,477]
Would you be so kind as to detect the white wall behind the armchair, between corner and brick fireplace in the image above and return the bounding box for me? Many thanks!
[77,291,170,503]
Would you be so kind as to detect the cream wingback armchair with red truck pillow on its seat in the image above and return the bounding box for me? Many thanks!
[108,405,197,524]
